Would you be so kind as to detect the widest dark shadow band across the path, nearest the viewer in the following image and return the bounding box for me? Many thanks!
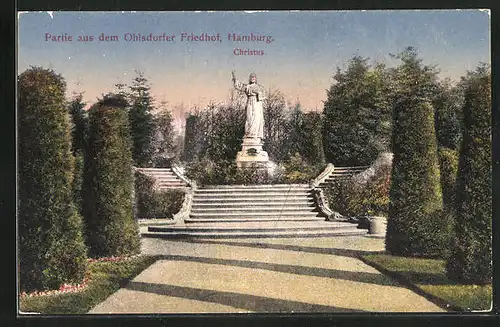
[126,281,364,312]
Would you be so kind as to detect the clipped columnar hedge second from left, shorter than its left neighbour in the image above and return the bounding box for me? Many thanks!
[84,94,139,257]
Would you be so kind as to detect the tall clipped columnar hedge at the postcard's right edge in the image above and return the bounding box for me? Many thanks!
[447,66,492,284]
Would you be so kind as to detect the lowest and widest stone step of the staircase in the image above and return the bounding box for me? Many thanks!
[142,228,367,238]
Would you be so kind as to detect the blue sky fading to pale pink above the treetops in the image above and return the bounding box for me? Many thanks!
[18,10,490,122]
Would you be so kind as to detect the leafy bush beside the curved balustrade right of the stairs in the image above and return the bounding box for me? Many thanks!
[325,160,391,217]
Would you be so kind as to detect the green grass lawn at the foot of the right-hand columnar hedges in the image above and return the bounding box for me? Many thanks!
[361,254,492,311]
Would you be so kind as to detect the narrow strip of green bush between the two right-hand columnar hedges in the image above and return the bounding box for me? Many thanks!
[438,148,458,210]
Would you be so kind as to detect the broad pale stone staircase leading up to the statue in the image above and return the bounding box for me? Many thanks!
[142,184,366,238]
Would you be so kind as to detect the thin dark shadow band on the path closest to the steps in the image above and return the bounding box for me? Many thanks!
[171,238,383,258]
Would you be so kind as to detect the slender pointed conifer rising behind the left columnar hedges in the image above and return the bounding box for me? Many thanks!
[129,71,155,167]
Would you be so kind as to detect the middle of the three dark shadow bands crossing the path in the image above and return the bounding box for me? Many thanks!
[160,255,399,286]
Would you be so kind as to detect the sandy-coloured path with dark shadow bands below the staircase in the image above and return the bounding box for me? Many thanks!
[90,236,443,314]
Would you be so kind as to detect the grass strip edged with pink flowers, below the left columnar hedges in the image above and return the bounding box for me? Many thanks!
[19,256,158,314]
